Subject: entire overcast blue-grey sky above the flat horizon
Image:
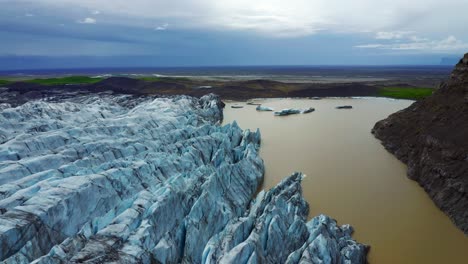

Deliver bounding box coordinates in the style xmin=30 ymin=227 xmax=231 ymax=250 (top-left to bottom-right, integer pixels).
xmin=0 ymin=0 xmax=468 ymax=69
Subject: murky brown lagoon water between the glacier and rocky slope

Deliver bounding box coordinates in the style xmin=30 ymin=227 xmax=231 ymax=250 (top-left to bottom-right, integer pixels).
xmin=224 ymin=98 xmax=468 ymax=264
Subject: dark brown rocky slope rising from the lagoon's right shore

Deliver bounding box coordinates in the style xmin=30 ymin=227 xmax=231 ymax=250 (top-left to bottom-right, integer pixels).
xmin=372 ymin=54 xmax=468 ymax=234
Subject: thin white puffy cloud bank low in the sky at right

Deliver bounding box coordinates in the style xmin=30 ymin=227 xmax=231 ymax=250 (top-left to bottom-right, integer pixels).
xmin=354 ymin=36 xmax=468 ymax=53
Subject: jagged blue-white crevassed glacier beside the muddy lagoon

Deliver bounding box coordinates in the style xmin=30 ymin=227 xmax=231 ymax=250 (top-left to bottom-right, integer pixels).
xmin=0 ymin=93 xmax=369 ymax=263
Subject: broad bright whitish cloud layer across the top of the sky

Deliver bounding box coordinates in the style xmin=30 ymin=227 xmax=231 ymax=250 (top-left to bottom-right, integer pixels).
xmin=18 ymin=0 xmax=468 ymax=39
